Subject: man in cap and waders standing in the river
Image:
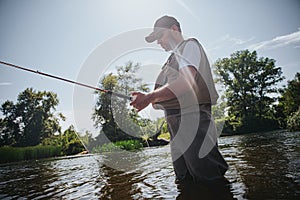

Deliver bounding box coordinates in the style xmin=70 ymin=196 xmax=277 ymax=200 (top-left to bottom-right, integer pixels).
xmin=131 ymin=16 xmax=228 ymax=182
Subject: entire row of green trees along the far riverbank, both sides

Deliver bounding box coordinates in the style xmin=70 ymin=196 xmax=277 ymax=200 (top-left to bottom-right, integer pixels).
xmin=0 ymin=50 xmax=300 ymax=150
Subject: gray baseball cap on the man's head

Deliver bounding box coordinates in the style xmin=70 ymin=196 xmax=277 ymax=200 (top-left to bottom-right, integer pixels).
xmin=145 ymin=15 xmax=180 ymax=43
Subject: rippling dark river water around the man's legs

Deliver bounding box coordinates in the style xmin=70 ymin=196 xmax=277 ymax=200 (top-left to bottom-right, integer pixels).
xmin=0 ymin=131 xmax=300 ymax=200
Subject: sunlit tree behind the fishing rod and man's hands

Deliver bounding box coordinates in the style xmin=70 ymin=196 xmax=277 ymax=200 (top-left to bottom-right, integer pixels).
xmin=92 ymin=62 xmax=148 ymax=142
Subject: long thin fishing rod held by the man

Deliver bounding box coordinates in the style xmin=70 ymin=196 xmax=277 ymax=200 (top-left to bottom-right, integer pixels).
xmin=0 ymin=61 xmax=132 ymax=101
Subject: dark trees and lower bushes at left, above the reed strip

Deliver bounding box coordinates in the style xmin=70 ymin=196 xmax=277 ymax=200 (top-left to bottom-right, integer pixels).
xmin=0 ymin=88 xmax=84 ymax=155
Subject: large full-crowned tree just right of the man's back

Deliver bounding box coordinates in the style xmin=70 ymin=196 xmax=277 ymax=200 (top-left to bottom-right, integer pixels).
xmin=215 ymin=50 xmax=284 ymax=132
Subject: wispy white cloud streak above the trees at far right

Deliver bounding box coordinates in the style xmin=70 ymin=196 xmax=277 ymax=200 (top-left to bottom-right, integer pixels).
xmin=248 ymin=28 xmax=300 ymax=50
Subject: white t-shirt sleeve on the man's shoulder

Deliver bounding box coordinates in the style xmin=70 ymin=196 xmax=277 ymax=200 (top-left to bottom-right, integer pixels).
xmin=178 ymin=41 xmax=201 ymax=69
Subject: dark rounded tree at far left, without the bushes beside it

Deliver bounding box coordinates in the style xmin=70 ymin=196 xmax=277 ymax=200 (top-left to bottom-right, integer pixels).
xmin=0 ymin=88 xmax=64 ymax=146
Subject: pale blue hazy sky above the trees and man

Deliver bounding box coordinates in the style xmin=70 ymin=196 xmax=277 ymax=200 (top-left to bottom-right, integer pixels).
xmin=0 ymin=0 xmax=300 ymax=134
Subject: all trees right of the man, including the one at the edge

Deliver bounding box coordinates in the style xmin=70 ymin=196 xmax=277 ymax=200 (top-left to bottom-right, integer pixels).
xmin=215 ymin=50 xmax=300 ymax=134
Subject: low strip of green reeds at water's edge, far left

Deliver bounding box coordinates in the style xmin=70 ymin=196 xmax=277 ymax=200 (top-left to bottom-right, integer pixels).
xmin=0 ymin=145 xmax=61 ymax=163
